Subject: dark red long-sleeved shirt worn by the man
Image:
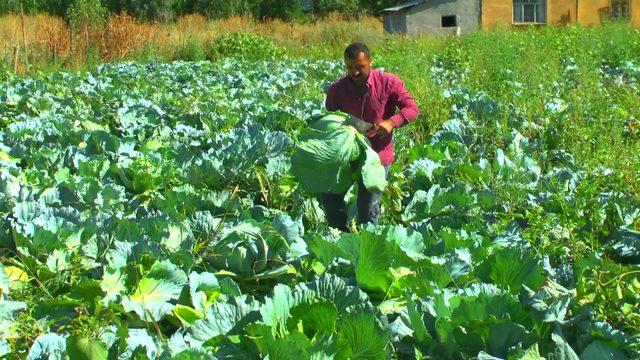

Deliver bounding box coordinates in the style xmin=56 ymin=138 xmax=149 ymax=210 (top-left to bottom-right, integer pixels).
xmin=325 ymin=69 xmax=420 ymax=165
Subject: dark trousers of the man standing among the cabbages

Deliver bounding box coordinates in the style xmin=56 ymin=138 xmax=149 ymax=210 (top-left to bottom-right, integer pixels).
xmin=320 ymin=166 xmax=389 ymax=232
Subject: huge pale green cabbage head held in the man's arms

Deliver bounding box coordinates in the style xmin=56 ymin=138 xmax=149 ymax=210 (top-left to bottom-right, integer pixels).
xmin=291 ymin=113 xmax=387 ymax=194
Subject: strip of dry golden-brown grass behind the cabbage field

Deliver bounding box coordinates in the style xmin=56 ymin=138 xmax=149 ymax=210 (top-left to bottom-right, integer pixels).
xmin=0 ymin=14 xmax=384 ymax=69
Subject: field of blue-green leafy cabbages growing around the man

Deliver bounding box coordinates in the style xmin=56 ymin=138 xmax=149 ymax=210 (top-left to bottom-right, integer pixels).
xmin=0 ymin=58 xmax=640 ymax=360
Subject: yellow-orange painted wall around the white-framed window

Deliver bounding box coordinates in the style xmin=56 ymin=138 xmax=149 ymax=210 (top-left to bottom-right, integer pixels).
xmin=482 ymin=0 xmax=640 ymax=29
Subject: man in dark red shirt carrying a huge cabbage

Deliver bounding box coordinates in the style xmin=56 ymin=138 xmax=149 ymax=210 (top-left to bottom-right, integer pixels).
xmin=321 ymin=43 xmax=419 ymax=231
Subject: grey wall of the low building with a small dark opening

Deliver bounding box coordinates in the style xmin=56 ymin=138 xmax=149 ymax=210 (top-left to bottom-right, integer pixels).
xmin=407 ymin=0 xmax=480 ymax=36
